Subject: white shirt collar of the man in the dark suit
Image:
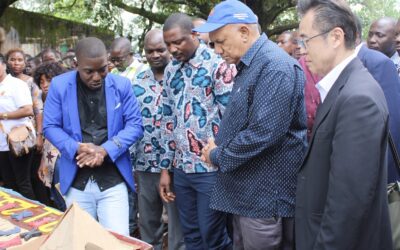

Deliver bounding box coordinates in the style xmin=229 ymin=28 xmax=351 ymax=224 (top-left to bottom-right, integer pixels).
xmin=316 ymin=52 xmax=356 ymax=103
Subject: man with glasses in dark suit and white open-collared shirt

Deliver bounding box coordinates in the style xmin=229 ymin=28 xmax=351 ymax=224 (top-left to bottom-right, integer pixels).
xmin=295 ymin=0 xmax=392 ymax=250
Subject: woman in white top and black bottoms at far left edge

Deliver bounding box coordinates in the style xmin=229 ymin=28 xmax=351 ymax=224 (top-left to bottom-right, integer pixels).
xmin=0 ymin=54 xmax=35 ymax=199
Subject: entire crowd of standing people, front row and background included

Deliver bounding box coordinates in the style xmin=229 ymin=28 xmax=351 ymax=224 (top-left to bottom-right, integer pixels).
xmin=0 ymin=0 xmax=400 ymax=250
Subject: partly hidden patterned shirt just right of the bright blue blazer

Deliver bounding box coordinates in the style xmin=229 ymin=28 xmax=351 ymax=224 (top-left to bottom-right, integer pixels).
xmin=131 ymin=69 xmax=165 ymax=173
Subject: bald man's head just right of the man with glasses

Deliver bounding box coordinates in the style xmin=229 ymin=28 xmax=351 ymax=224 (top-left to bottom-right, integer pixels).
xmin=367 ymin=17 xmax=396 ymax=57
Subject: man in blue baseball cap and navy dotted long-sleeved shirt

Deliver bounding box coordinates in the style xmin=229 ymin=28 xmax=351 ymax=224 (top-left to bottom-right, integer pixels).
xmin=198 ymin=0 xmax=306 ymax=249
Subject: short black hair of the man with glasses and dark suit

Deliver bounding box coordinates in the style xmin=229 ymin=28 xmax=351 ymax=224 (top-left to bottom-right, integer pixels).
xmin=297 ymin=0 xmax=357 ymax=49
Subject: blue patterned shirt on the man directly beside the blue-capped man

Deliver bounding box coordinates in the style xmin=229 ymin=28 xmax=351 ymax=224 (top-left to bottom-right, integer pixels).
xmin=160 ymin=44 xmax=236 ymax=173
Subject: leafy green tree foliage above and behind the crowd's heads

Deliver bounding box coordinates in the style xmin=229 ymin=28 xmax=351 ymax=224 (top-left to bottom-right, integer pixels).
xmin=7 ymin=0 xmax=400 ymax=48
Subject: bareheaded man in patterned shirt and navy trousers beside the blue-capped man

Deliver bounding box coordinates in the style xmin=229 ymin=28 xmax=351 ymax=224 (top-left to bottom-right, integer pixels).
xmin=159 ymin=13 xmax=236 ymax=250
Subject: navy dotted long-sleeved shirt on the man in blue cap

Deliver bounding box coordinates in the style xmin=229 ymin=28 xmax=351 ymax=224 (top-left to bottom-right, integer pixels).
xmin=210 ymin=34 xmax=307 ymax=218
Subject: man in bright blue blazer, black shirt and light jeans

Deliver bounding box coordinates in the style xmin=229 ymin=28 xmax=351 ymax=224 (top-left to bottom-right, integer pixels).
xmin=43 ymin=37 xmax=143 ymax=235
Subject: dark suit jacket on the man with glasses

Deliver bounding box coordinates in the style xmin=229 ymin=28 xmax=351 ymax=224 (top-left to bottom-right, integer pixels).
xmin=295 ymin=58 xmax=392 ymax=250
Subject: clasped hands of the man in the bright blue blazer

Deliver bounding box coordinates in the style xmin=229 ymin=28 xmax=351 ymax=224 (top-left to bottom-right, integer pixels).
xmin=76 ymin=143 xmax=107 ymax=168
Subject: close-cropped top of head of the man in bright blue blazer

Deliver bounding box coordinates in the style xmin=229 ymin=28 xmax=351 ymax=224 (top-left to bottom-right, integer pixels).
xmin=75 ymin=37 xmax=107 ymax=63
